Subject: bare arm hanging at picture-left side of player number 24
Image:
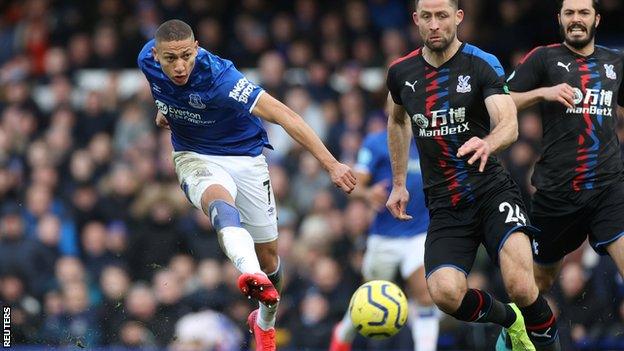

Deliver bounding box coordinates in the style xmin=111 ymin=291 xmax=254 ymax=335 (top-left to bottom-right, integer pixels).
xmin=386 ymin=94 xmax=412 ymax=221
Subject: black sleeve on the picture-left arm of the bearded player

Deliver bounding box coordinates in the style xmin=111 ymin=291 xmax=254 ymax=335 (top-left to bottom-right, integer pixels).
xmin=507 ymin=47 xmax=546 ymax=93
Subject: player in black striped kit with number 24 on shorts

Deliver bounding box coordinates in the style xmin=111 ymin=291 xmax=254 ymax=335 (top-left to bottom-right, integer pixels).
xmin=387 ymin=0 xmax=560 ymax=350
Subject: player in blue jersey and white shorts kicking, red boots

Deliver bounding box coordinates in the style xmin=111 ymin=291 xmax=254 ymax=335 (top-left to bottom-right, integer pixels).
xmin=138 ymin=20 xmax=356 ymax=351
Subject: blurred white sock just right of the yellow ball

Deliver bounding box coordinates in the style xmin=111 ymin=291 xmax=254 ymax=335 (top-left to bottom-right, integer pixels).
xmin=410 ymin=303 xmax=440 ymax=351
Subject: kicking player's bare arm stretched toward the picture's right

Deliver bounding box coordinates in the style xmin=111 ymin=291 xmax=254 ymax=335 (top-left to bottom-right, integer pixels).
xmin=252 ymin=92 xmax=356 ymax=193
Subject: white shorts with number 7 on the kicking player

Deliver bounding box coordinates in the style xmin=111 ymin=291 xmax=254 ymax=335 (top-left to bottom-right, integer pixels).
xmin=173 ymin=151 xmax=277 ymax=243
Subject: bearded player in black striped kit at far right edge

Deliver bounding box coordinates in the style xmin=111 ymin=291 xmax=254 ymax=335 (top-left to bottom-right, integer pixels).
xmin=508 ymin=0 xmax=624 ymax=320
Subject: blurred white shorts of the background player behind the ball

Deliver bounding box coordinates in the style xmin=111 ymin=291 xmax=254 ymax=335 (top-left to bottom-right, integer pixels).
xmin=362 ymin=233 xmax=426 ymax=281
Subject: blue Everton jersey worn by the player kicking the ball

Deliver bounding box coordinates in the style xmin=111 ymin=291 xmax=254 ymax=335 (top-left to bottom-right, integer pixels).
xmin=138 ymin=39 xmax=271 ymax=156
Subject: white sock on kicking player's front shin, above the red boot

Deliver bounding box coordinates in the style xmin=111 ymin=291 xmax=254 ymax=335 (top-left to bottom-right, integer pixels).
xmin=218 ymin=227 xmax=262 ymax=273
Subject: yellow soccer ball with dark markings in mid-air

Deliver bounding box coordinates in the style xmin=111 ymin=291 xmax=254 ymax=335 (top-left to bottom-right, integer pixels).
xmin=349 ymin=280 xmax=407 ymax=339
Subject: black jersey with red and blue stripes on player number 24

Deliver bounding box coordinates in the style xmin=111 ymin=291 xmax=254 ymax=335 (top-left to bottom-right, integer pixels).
xmin=387 ymin=43 xmax=508 ymax=208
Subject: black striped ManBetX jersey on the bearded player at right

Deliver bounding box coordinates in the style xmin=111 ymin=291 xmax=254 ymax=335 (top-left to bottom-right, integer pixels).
xmin=508 ymin=44 xmax=624 ymax=191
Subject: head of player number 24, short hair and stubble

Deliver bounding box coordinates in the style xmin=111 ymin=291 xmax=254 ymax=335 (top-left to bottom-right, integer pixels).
xmin=412 ymin=0 xmax=464 ymax=52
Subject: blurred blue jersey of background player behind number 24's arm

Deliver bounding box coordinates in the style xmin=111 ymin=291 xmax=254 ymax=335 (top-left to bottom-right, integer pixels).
xmin=355 ymin=131 xmax=429 ymax=237
